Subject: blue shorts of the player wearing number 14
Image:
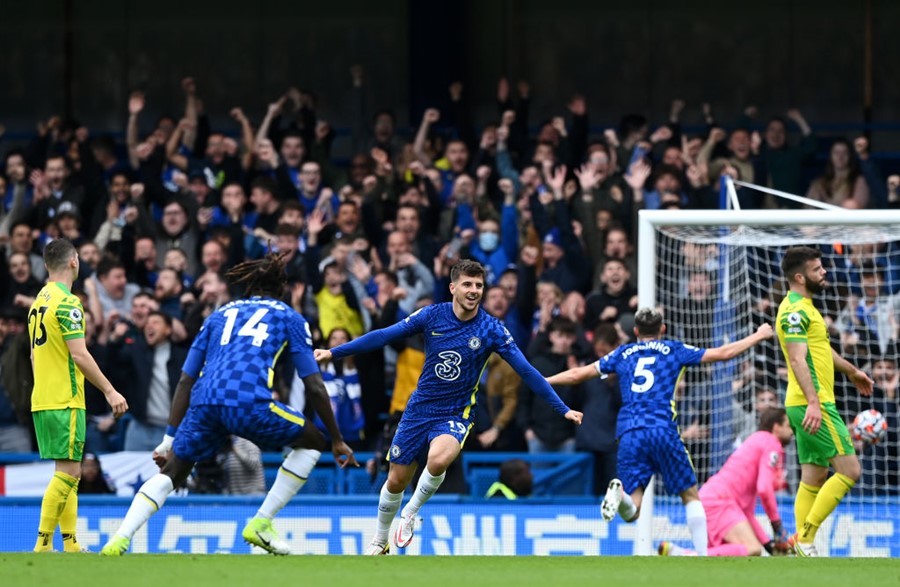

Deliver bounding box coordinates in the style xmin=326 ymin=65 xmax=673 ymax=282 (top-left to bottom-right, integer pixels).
xmin=172 ymin=401 xmax=306 ymax=463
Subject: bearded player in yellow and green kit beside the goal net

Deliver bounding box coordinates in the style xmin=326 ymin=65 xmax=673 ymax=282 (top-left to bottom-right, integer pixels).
xmin=776 ymin=247 xmax=872 ymax=556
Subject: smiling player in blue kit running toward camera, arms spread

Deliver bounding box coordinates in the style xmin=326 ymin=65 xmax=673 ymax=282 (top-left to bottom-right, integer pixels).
xmin=315 ymin=259 xmax=582 ymax=555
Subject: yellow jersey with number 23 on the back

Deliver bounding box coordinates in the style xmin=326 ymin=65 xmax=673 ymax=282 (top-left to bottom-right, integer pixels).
xmin=28 ymin=281 xmax=84 ymax=412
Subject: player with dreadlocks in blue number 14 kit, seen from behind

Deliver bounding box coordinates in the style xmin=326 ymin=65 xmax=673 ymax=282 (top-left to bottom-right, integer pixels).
xmin=101 ymin=253 xmax=358 ymax=556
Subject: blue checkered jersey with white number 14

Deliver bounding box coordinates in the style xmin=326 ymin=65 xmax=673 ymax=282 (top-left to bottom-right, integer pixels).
xmin=184 ymin=297 xmax=319 ymax=407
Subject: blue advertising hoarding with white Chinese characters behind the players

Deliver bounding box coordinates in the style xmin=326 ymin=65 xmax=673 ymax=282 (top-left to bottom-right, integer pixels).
xmin=0 ymin=496 xmax=900 ymax=557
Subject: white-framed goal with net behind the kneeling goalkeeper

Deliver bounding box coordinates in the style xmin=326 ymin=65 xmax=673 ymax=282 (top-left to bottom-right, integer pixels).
xmin=637 ymin=210 xmax=900 ymax=556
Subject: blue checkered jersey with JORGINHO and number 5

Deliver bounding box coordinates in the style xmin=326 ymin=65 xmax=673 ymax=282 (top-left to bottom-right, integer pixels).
xmin=594 ymin=340 xmax=706 ymax=438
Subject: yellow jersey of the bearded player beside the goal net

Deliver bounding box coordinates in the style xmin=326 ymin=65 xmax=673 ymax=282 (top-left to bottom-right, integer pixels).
xmin=775 ymin=292 xmax=834 ymax=406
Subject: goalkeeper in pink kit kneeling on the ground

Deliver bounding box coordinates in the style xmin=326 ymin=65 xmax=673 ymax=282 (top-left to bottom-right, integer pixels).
xmin=659 ymin=408 xmax=794 ymax=556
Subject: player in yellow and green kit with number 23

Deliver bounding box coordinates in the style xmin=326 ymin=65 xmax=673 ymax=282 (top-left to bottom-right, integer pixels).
xmin=28 ymin=239 xmax=128 ymax=552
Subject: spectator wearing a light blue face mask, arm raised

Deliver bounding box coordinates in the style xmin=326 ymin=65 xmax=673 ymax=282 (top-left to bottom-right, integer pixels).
xmin=457 ymin=180 xmax=519 ymax=286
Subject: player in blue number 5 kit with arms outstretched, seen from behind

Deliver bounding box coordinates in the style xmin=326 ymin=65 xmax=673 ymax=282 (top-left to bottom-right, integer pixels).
xmin=547 ymin=308 xmax=773 ymax=556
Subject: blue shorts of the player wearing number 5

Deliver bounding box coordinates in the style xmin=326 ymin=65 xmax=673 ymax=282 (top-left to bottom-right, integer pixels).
xmin=616 ymin=428 xmax=697 ymax=494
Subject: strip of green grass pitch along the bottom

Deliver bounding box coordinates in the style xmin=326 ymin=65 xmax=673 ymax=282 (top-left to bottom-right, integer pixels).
xmin=0 ymin=553 xmax=900 ymax=587
